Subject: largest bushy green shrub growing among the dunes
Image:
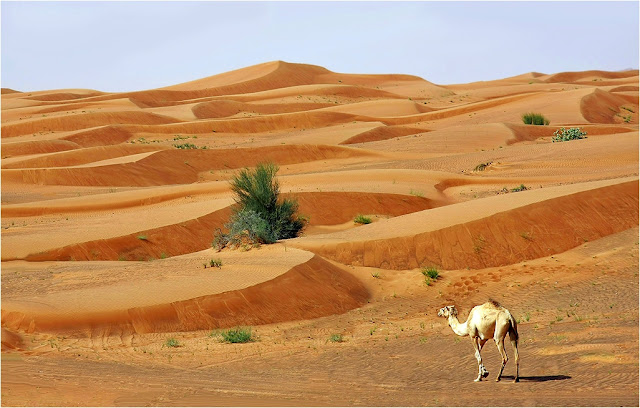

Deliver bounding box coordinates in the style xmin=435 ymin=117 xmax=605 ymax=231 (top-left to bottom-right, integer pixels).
xmin=212 ymin=163 xmax=307 ymax=249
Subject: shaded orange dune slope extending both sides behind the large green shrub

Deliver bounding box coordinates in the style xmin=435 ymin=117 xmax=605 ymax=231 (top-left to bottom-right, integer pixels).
xmin=16 ymin=192 xmax=443 ymax=261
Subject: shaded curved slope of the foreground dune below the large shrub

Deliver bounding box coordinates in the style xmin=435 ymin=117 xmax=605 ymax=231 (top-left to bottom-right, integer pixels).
xmin=2 ymin=256 xmax=369 ymax=337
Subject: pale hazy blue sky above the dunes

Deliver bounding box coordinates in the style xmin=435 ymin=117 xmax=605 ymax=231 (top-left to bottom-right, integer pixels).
xmin=0 ymin=1 xmax=639 ymax=91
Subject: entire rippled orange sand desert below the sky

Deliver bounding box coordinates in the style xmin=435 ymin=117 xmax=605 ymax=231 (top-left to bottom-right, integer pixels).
xmin=1 ymin=61 xmax=639 ymax=406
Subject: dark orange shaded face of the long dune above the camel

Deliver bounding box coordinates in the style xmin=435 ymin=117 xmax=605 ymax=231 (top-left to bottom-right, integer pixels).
xmin=296 ymin=181 xmax=638 ymax=269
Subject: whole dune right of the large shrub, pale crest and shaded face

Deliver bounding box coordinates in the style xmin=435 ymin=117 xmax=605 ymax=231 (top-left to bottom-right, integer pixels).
xmin=292 ymin=180 xmax=638 ymax=269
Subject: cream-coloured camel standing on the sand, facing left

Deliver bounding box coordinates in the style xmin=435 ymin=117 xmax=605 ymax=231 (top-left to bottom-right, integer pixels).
xmin=438 ymin=300 xmax=520 ymax=382
